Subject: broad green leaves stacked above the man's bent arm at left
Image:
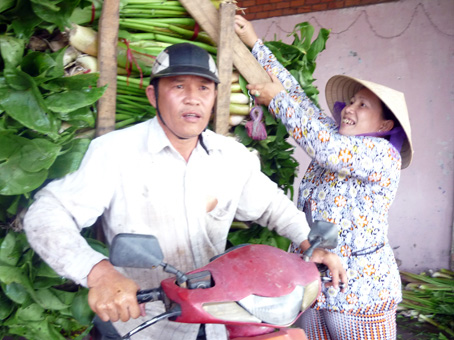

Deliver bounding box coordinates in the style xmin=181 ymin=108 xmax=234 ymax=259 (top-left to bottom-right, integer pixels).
xmin=0 ymin=0 xmax=105 ymax=224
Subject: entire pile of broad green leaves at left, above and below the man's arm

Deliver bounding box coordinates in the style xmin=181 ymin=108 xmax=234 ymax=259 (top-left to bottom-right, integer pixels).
xmin=0 ymin=0 xmax=105 ymax=340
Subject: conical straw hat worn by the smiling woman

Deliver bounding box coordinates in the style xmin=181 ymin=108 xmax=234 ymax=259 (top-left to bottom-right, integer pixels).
xmin=325 ymin=75 xmax=413 ymax=169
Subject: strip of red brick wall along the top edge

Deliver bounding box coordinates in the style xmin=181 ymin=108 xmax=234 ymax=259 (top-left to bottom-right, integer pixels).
xmin=237 ymin=0 xmax=396 ymax=20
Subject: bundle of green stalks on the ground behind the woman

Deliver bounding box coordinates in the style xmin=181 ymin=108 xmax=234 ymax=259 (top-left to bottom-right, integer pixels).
xmin=398 ymin=269 xmax=454 ymax=339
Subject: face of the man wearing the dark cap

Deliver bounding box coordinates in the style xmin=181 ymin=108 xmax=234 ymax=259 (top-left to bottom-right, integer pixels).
xmin=147 ymin=75 xmax=217 ymax=142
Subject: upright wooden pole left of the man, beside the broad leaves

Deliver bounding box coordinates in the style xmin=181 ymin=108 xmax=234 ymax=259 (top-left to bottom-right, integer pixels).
xmin=95 ymin=0 xmax=120 ymax=137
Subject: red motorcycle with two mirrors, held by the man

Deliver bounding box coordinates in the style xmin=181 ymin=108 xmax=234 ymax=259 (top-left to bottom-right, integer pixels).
xmin=110 ymin=221 xmax=337 ymax=340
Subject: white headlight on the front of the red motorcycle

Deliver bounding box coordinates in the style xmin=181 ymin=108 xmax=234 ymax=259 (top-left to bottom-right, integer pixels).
xmin=238 ymin=286 xmax=304 ymax=326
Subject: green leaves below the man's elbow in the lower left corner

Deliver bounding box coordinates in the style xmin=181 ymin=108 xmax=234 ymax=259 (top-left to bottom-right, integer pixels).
xmin=0 ymin=229 xmax=107 ymax=340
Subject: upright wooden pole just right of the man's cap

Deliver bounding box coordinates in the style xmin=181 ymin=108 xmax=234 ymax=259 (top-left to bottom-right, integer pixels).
xmin=214 ymin=2 xmax=236 ymax=135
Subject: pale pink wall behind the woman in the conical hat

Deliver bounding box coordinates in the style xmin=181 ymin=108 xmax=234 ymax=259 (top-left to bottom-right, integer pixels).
xmin=246 ymin=0 xmax=454 ymax=272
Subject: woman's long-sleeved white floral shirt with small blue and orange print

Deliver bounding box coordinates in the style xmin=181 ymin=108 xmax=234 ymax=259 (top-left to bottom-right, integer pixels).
xmin=252 ymin=40 xmax=402 ymax=313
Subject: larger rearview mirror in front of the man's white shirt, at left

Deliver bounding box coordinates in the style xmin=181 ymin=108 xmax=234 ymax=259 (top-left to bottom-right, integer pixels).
xmin=110 ymin=233 xmax=164 ymax=268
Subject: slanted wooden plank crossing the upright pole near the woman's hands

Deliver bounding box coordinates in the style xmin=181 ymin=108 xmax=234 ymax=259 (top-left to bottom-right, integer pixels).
xmin=180 ymin=0 xmax=271 ymax=84
